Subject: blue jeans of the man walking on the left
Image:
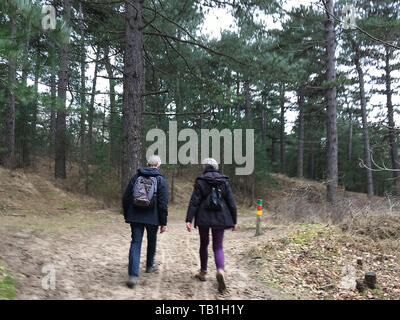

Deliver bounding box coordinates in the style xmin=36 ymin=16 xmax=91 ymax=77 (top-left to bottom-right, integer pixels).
xmin=128 ymin=222 xmax=158 ymax=276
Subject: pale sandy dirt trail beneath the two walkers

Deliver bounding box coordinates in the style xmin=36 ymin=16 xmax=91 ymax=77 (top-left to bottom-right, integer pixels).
xmin=0 ymin=217 xmax=280 ymax=300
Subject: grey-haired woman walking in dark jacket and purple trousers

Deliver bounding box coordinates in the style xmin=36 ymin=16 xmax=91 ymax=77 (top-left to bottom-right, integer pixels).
xmin=186 ymin=158 xmax=237 ymax=293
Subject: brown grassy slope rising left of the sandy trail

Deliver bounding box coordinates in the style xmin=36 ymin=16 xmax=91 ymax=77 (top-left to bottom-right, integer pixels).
xmin=0 ymin=162 xmax=118 ymax=230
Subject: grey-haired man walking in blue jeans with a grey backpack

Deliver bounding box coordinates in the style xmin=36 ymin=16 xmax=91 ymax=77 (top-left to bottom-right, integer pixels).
xmin=122 ymin=155 xmax=168 ymax=288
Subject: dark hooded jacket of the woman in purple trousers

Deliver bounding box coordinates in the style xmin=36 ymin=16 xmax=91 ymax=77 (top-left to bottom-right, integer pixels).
xmin=186 ymin=169 xmax=237 ymax=228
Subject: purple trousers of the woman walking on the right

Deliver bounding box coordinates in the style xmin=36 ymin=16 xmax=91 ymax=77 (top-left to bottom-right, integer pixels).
xmin=199 ymin=226 xmax=225 ymax=271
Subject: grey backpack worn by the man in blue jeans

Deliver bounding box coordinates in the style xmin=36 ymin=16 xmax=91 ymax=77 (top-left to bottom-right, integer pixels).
xmin=132 ymin=176 xmax=157 ymax=208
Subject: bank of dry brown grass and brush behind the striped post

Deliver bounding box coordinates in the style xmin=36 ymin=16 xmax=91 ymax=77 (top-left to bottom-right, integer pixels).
xmin=266 ymin=175 xmax=400 ymax=226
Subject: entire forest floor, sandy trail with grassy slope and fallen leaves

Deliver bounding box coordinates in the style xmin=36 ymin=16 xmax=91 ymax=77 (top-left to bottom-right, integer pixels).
xmin=0 ymin=167 xmax=400 ymax=300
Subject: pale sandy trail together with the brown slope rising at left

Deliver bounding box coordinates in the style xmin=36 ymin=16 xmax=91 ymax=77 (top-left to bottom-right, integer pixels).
xmin=0 ymin=168 xmax=287 ymax=300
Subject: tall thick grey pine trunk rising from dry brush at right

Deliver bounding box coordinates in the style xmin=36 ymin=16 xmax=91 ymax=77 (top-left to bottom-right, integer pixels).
xmin=325 ymin=0 xmax=338 ymax=203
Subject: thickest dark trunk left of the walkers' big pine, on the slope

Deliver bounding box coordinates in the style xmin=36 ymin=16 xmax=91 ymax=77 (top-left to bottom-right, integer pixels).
xmin=55 ymin=0 xmax=71 ymax=179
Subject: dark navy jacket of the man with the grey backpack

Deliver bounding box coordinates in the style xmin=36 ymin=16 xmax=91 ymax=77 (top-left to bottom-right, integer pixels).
xmin=122 ymin=167 xmax=168 ymax=226
